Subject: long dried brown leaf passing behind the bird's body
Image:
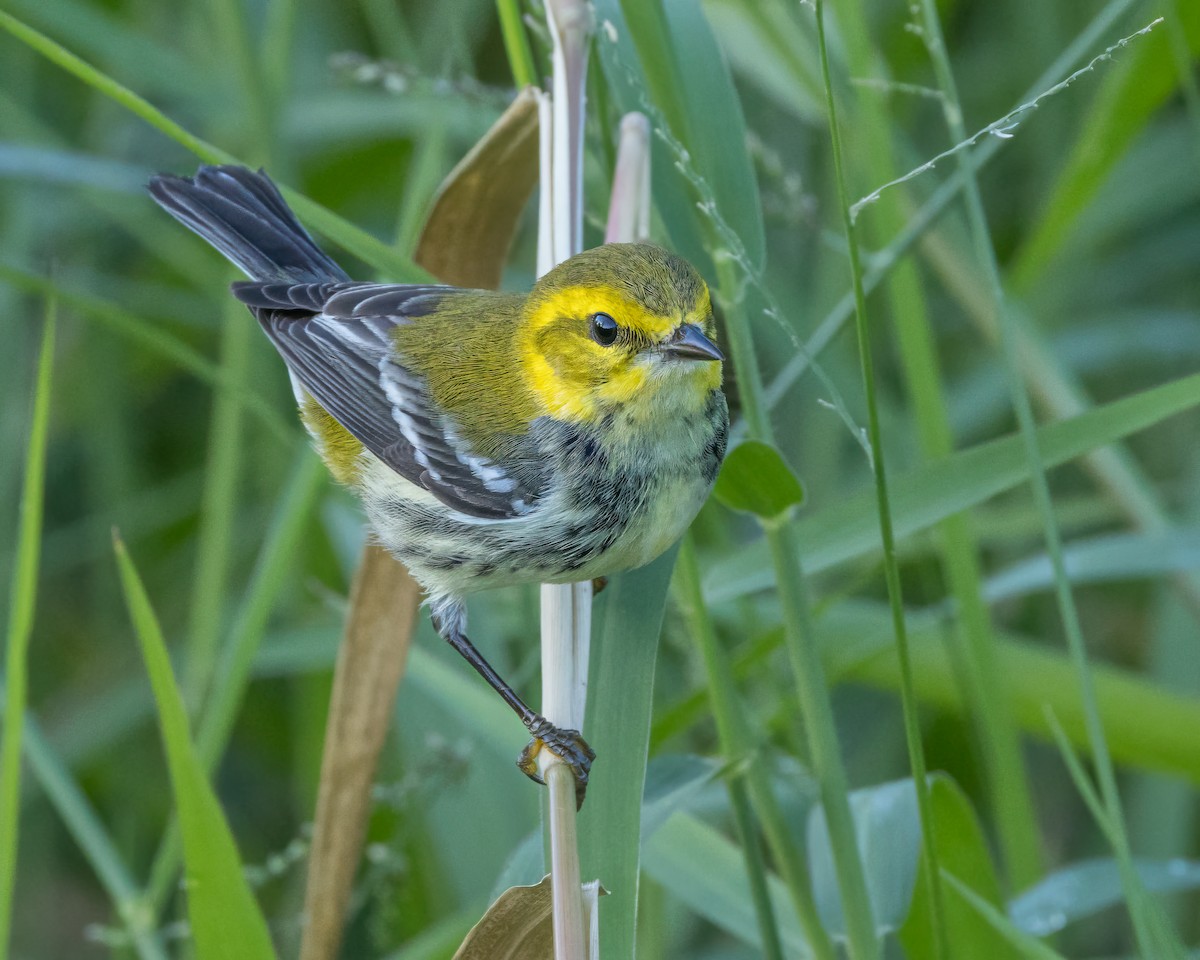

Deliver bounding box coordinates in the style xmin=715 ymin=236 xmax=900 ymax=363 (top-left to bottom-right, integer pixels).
xmin=300 ymin=90 xmax=538 ymax=960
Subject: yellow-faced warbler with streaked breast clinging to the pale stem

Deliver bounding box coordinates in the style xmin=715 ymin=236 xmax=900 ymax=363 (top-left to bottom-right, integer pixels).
xmin=149 ymin=166 xmax=728 ymax=804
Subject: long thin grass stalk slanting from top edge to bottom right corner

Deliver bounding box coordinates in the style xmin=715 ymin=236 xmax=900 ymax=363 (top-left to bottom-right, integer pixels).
xmin=907 ymin=0 xmax=1182 ymax=956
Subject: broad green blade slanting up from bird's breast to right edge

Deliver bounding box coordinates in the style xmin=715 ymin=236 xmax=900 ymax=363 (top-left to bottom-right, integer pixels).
xmin=704 ymin=374 xmax=1200 ymax=602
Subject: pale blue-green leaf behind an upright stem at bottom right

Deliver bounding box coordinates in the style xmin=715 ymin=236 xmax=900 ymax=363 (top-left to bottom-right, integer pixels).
xmin=808 ymin=779 xmax=920 ymax=941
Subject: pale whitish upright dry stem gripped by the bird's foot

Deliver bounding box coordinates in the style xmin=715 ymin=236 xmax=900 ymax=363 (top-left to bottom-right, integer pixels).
xmin=538 ymin=0 xmax=592 ymax=960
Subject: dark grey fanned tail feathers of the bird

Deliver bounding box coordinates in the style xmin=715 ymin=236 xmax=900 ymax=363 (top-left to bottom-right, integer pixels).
xmin=150 ymin=167 xmax=349 ymax=283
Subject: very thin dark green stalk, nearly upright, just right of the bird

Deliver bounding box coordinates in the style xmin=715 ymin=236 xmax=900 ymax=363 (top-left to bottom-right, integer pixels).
xmin=816 ymin=0 xmax=947 ymax=958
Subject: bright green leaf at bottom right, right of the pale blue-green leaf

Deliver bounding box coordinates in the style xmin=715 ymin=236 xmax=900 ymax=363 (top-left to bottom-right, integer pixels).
xmin=900 ymin=773 xmax=1021 ymax=960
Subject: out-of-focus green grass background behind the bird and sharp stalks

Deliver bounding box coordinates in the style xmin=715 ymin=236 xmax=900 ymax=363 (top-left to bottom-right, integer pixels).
xmin=0 ymin=0 xmax=1200 ymax=960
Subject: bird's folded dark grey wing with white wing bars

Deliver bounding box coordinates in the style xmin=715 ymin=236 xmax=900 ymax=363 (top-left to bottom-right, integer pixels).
xmin=233 ymin=282 xmax=540 ymax=520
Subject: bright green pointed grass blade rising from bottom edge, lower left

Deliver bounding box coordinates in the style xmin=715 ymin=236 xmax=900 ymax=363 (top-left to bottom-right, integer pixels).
xmin=114 ymin=536 xmax=275 ymax=960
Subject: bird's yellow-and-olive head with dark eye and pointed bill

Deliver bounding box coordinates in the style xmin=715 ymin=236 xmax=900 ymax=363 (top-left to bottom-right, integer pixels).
xmin=518 ymin=244 xmax=725 ymax=421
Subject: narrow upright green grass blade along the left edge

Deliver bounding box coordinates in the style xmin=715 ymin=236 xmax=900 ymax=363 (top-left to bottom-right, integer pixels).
xmin=0 ymin=299 xmax=58 ymax=960
